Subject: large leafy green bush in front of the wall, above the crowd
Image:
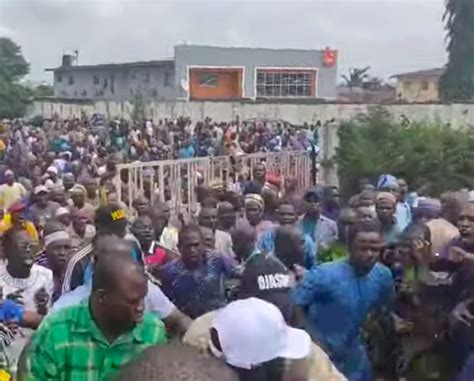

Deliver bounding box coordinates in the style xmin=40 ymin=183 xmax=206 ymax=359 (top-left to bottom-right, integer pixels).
xmin=336 ymin=107 xmax=474 ymax=195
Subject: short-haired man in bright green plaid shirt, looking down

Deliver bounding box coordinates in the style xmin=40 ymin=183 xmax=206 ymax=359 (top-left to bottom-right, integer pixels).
xmin=28 ymin=248 xmax=166 ymax=380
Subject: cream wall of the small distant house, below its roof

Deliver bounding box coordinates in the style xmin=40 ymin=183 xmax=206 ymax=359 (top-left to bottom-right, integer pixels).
xmin=397 ymin=78 xmax=439 ymax=102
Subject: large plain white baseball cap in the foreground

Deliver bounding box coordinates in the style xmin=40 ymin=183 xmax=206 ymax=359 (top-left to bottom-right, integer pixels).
xmin=213 ymin=298 xmax=311 ymax=369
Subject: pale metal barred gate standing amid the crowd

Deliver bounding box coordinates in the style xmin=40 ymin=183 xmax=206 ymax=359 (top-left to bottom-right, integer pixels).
xmin=115 ymin=151 xmax=313 ymax=215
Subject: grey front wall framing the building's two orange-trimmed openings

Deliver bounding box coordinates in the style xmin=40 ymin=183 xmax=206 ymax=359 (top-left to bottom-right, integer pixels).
xmin=175 ymin=45 xmax=337 ymax=99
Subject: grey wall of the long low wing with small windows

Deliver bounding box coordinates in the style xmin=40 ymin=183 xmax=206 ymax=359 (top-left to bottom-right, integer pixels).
xmin=54 ymin=63 xmax=176 ymax=101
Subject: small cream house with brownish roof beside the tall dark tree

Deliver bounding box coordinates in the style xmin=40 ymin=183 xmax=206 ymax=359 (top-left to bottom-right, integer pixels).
xmin=390 ymin=68 xmax=444 ymax=103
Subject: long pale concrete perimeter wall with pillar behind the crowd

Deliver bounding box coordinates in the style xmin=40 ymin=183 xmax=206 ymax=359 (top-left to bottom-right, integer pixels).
xmin=28 ymin=100 xmax=474 ymax=184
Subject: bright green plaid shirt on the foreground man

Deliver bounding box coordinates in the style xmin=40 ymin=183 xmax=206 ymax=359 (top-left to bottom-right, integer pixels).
xmin=27 ymin=299 xmax=166 ymax=381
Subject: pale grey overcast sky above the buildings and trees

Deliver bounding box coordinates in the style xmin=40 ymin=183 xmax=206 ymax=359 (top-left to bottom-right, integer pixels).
xmin=0 ymin=0 xmax=446 ymax=81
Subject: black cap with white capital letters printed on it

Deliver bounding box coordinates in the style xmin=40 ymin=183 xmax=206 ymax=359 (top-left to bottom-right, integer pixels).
xmin=239 ymin=254 xmax=293 ymax=322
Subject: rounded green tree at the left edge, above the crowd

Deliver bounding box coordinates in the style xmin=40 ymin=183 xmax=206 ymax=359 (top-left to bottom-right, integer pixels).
xmin=0 ymin=37 xmax=30 ymax=118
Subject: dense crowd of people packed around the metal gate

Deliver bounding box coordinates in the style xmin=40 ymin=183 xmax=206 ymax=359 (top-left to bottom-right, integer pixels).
xmin=0 ymin=117 xmax=474 ymax=381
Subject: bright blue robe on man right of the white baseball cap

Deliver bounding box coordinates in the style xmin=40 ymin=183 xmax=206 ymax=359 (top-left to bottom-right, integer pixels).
xmin=293 ymin=258 xmax=394 ymax=381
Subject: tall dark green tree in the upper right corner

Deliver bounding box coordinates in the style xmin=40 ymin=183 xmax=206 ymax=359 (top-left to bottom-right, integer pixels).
xmin=439 ymin=0 xmax=474 ymax=102
